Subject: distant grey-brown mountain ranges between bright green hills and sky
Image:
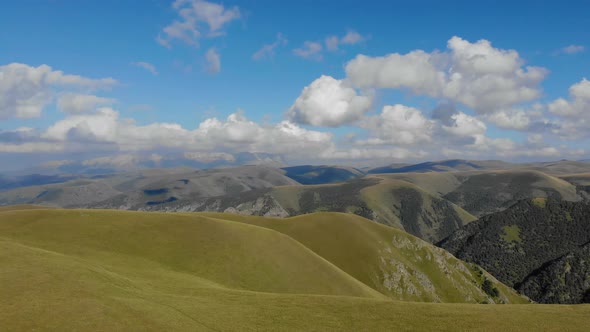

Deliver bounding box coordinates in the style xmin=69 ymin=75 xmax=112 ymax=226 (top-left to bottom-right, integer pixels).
xmin=0 ymin=166 xmax=590 ymax=243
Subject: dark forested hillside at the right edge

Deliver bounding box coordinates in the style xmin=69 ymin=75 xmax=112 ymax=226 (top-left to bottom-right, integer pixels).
xmin=440 ymin=198 xmax=590 ymax=303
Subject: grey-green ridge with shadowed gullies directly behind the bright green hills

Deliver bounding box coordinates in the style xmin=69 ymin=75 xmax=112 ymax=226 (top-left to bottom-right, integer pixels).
xmin=145 ymin=176 xmax=476 ymax=242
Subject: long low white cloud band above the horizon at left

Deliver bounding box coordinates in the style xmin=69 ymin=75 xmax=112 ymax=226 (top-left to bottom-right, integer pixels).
xmin=0 ymin=107 xmax=334 ymax=162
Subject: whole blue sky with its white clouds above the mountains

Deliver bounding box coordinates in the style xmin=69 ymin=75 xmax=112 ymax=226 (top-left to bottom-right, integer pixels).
xmin=0 ymin=0 xmax=590 ymax=168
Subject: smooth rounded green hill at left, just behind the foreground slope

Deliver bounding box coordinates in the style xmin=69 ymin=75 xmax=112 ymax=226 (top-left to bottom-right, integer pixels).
xmin=0 ymin=210 xmax=378 ymax=297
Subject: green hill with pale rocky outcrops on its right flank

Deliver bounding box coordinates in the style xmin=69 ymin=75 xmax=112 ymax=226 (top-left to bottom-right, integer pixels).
xmin=206 ymin=213 xmax=525 ymax=303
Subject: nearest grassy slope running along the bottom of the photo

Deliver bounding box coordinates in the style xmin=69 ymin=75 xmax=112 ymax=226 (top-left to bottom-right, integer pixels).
xmin=0 ymin=241 xmax=590 ymax=331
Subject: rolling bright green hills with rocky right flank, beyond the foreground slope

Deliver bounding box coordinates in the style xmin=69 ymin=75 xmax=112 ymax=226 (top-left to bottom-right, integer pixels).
xmin=0 ymin=208 xmax=522 ymax=302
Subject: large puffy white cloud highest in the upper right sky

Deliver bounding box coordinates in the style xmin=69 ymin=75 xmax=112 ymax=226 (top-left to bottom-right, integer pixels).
xmin=346 ymin=37 xmax=547 ymax=114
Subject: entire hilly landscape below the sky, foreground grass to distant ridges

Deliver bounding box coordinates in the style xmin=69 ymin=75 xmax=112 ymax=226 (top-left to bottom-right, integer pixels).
xmin=0 ymin=160 xmax=590 ymax=330
